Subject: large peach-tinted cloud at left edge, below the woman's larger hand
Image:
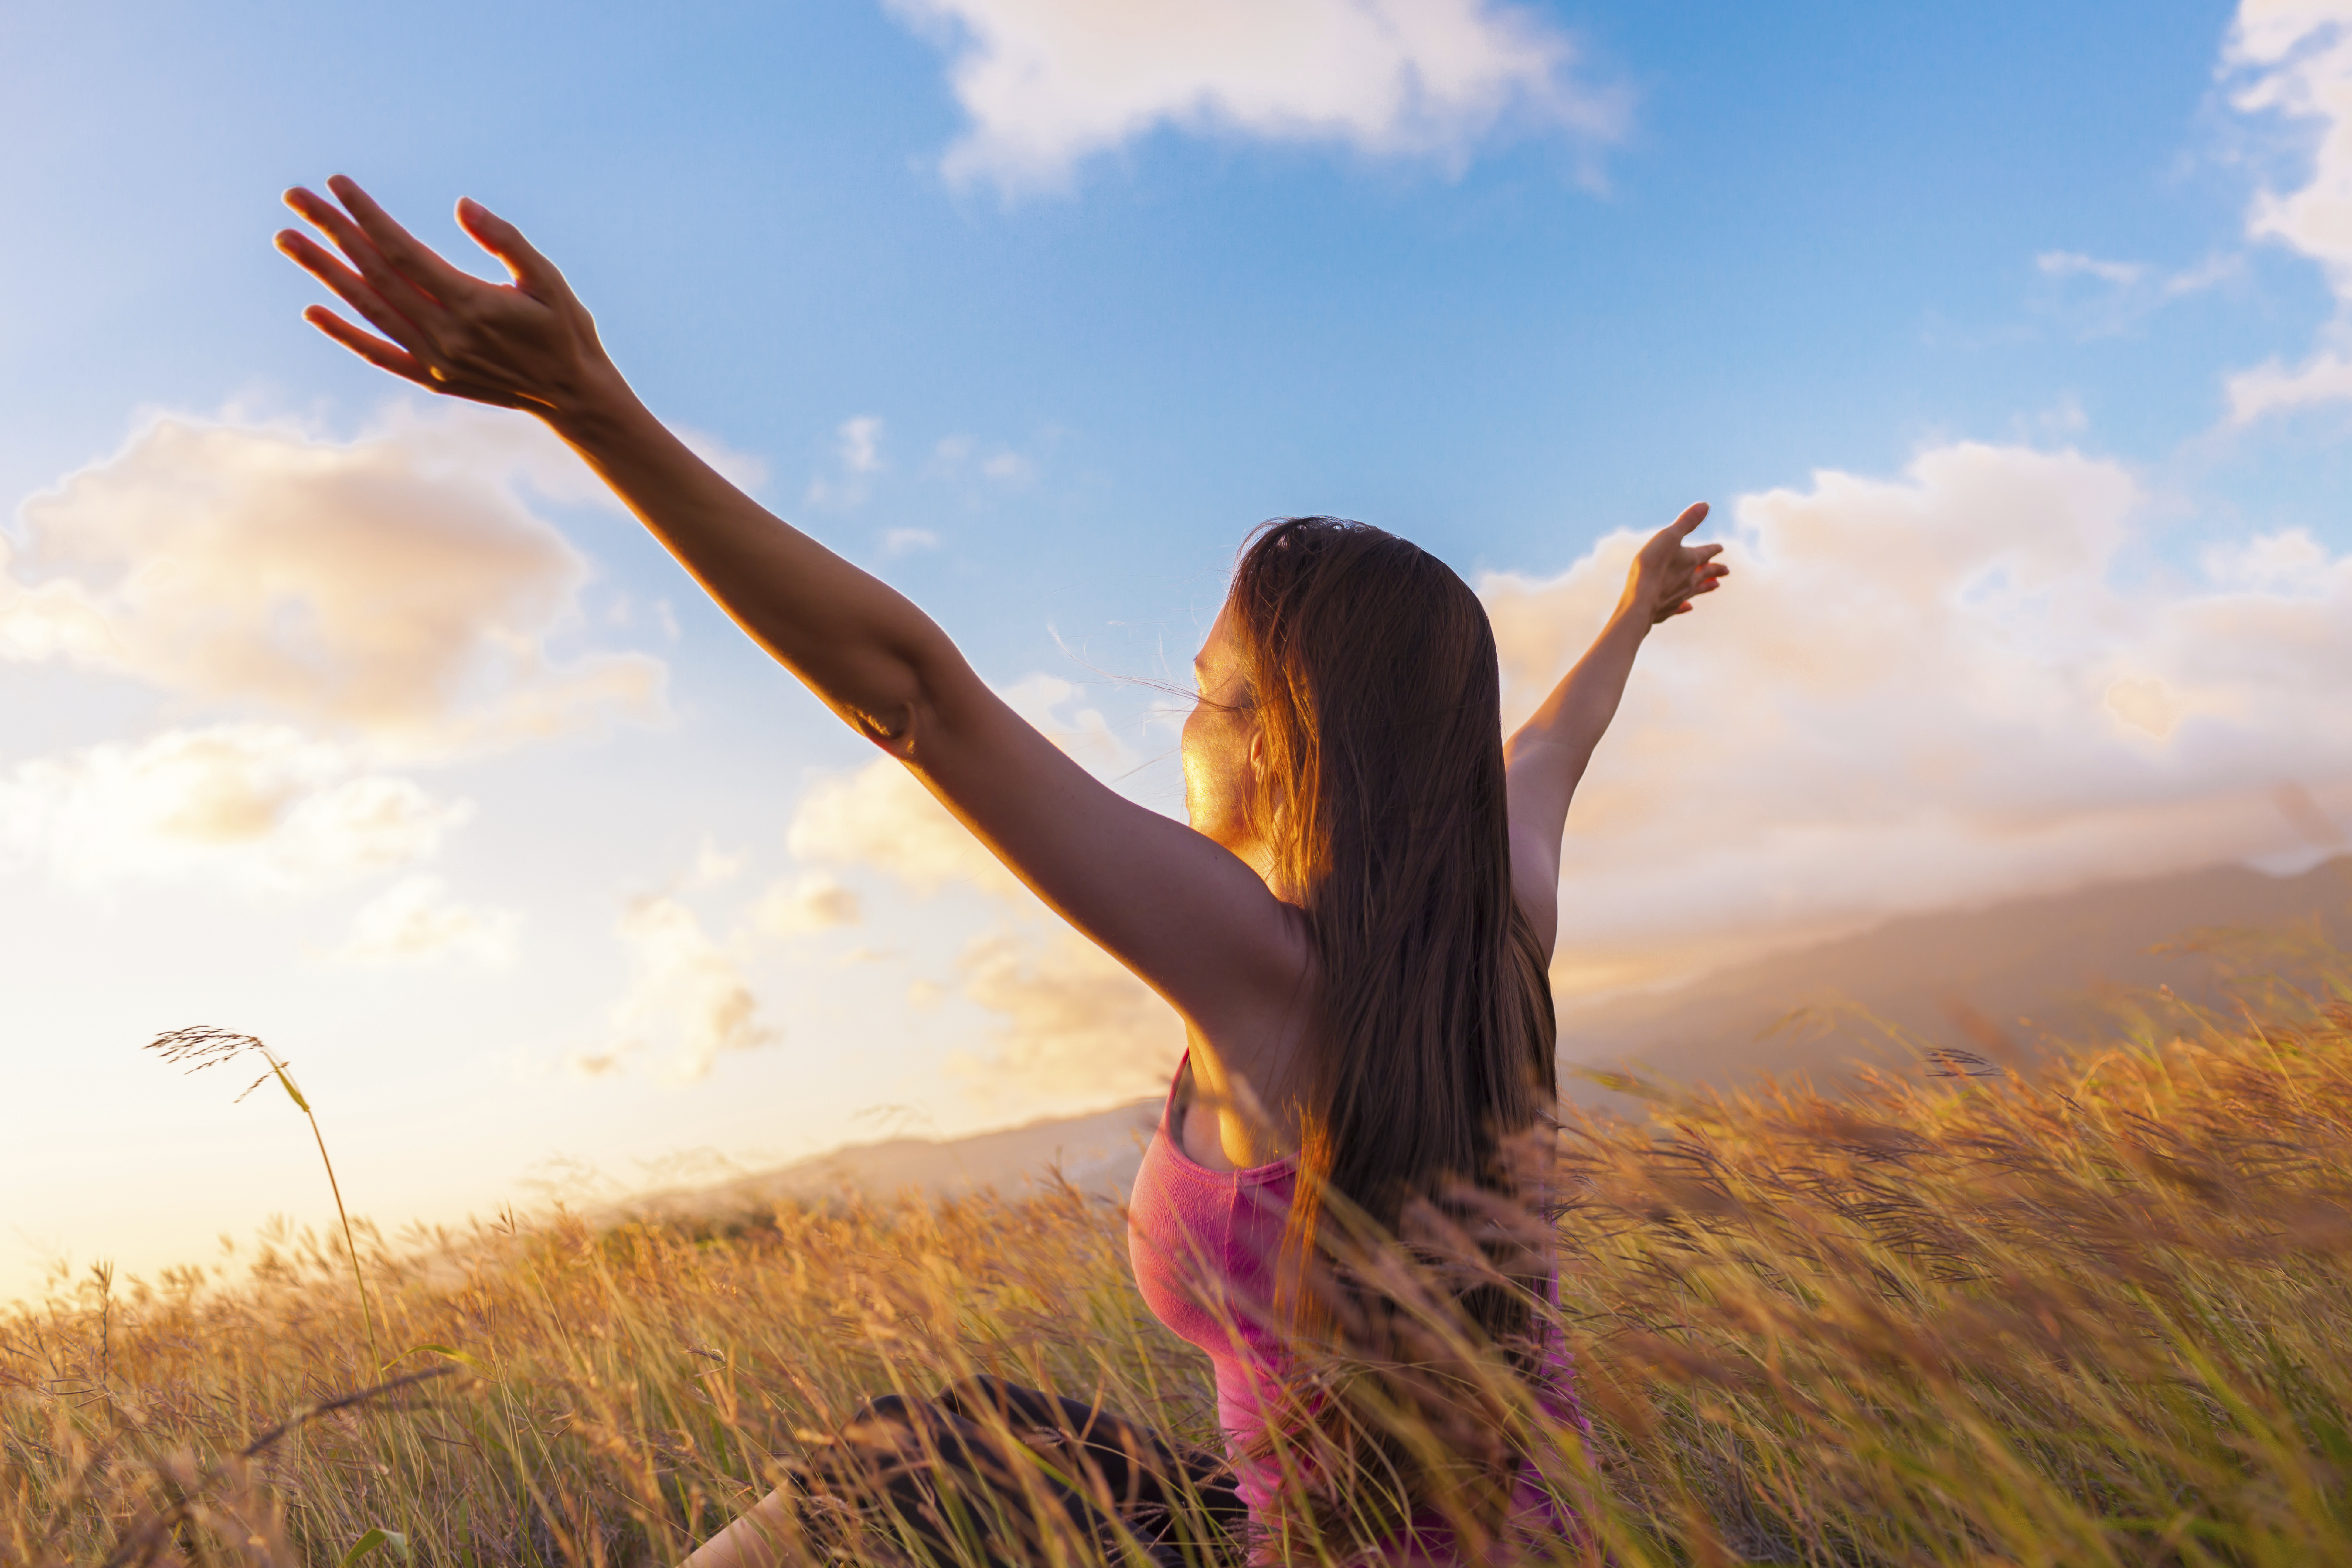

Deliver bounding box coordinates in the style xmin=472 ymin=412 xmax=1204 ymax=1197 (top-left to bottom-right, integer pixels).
xmin=0 ymin=418 xmax=663 ymax=752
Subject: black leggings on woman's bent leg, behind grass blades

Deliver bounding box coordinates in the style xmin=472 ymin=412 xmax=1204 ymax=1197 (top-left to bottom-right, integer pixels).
xmin=795 ymin=1377 xmax=1246 ymax=1568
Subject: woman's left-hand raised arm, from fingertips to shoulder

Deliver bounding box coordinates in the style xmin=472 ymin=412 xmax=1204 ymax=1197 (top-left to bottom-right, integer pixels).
xmin=277 ymin=176 xmax=1305 ymax=1039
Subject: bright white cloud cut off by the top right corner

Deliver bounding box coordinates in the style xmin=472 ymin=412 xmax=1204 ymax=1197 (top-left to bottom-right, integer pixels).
xmin=2225 ymin=0 xmax=2352 ymax=421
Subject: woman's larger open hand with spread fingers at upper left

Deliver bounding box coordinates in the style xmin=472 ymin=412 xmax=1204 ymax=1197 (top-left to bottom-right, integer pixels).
xmin=277 ymin=174 xmax=621 ymax=418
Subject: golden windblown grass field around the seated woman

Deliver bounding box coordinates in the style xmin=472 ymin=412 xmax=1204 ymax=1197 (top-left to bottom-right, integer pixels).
xmin=0 ymin=971 xmax=2352 ymax=1568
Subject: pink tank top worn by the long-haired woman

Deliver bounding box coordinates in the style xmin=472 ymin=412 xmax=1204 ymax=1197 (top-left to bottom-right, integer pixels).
xmin=1127 ymin=1053 xmax=1590 ymax=1566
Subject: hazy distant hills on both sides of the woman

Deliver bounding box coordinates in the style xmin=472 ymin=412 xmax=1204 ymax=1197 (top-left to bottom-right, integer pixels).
xmin=626 ymin=856 xmax=2352 ymax=1216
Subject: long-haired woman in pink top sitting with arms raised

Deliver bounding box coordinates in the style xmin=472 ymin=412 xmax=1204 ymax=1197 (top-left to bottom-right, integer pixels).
xmin=277 ymin=179 xmax=1726 ymax=1563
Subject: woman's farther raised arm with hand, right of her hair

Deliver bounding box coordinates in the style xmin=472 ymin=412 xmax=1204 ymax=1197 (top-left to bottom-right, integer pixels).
xmin=1503 ymin=501 xmax=1731 ymax=952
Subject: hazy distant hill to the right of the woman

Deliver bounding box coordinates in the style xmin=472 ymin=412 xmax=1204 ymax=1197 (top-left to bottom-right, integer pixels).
xmin=1559 ymin=856 xmax=2352 ymax=1107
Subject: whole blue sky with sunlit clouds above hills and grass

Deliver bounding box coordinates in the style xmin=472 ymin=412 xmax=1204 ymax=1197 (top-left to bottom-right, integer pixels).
xmin=0 ymin=0 xmax=2352 ymax=1293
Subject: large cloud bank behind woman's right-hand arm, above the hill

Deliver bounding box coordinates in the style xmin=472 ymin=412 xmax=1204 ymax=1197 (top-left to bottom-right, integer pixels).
xmin=1482 ymin=444 xmax=2352 ymax=990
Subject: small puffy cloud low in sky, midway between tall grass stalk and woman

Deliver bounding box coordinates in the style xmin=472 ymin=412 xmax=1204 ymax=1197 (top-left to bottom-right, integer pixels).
xmin=593 ymin=896 xmax=778 ymax=1084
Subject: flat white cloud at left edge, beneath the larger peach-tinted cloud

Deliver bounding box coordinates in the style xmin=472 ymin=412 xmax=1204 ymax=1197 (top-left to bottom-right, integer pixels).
xmin=0 ymin=724 xmax=473 ymax=891
